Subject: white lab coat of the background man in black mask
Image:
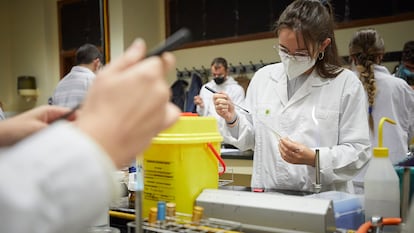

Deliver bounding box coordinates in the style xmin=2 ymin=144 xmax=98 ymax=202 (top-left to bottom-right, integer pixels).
xmin=197 ymin=76 xmax=245 ymax=135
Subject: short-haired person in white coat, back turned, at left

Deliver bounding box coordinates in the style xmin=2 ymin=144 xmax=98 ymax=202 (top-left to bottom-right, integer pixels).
xmin=49 ymin=44 xmax=103 ymax=108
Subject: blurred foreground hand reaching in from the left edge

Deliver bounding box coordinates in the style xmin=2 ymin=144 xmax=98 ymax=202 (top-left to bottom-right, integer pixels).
xmin=0 ymin=105 xmax=74 ymax=146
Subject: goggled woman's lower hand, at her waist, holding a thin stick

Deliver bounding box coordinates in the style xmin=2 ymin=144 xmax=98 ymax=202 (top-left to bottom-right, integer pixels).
xmin=279 ymin=138 xmax=315 ymax=167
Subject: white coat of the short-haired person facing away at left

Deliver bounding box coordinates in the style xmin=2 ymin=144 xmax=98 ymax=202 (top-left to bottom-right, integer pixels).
xmin=52 ymin=66 xmax=95 ymax=108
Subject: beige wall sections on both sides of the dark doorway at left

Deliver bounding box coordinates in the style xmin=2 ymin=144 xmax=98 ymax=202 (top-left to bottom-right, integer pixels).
xmin=0 ymin=0 xmax=165 ymax=115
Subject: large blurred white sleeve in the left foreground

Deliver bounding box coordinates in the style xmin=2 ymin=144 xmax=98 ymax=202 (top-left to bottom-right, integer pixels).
xmin=0 ymin=123 xmax=117 ymax=233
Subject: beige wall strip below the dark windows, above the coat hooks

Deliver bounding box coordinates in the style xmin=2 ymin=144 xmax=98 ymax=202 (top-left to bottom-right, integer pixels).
xmin=169 ymin=20 xmax=414 ymax=81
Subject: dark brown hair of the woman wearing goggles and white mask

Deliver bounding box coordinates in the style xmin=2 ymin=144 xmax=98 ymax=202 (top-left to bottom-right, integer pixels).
xmin=275 ymin=0 xmax=343 ymax=78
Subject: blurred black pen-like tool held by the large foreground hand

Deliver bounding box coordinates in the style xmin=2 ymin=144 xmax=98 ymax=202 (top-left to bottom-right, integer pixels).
xmin=56 ymin=28 xmax=191 ymax=120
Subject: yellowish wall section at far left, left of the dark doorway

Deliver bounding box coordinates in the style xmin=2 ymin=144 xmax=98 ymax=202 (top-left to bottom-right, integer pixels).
xmin=0 ymin=0 xmax=58 ymax=113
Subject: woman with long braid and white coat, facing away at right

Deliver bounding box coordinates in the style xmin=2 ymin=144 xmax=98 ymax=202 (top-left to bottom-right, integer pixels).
xmin=349 ymin=28 xmax=414 ymax=191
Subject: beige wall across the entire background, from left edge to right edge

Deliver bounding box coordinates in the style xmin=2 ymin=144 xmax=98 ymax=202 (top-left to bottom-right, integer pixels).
xmin=0 ymin=0 xmax=414 ymax=113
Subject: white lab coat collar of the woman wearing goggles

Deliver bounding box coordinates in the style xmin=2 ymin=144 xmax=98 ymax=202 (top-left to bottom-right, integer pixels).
xmin=271 ymin=69 xmax=330 ymax=108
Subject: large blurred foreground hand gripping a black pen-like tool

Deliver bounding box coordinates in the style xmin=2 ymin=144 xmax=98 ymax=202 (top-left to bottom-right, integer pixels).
xmin=74 ymin=40 xmax=180 ymax=168
